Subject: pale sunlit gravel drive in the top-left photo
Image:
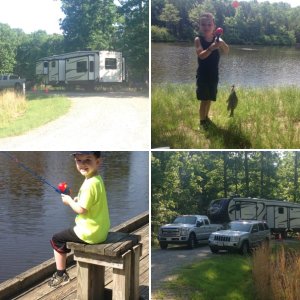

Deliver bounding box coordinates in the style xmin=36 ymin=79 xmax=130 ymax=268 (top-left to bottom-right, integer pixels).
xmin=0 ymin=92 xmax=150 ymax=151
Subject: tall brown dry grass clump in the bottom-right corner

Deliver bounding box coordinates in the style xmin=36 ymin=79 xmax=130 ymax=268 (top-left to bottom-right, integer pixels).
xmin=253 ymin=246 xmax=300 ymax=300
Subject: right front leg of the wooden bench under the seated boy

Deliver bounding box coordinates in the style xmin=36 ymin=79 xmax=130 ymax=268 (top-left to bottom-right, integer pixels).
xmin=112 ymin=250 xmax=131 ymax=300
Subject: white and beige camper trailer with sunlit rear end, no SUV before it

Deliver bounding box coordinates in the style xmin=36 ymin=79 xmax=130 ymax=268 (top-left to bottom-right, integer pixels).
xmin=36 ymin=51 xmax=126 ymax=87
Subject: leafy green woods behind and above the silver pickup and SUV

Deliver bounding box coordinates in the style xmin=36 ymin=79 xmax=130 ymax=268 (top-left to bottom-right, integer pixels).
xmin=151 ymin=151 xmax=300 ymax=224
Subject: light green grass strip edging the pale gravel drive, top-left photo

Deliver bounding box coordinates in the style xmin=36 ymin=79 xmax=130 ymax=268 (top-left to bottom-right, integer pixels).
xmin=0 ymin=94 xmax=71 ymax=138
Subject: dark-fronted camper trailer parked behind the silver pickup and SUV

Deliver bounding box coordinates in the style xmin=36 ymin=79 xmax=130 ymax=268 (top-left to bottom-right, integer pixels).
xmin=207 ymin=197 xmax=300 ymax=234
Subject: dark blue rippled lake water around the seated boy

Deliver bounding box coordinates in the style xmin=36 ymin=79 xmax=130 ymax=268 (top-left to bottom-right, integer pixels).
xmin=0 ymin=152 xmax=149 ymax=282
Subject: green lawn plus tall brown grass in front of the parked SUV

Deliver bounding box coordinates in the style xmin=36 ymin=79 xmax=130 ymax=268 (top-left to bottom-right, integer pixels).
xmin=153 ymin=240 xmax=300 ymax=300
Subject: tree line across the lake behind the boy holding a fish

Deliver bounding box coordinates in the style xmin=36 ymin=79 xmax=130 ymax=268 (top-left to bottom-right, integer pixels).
xmin=151 ymin=0 xmax=300 ymax=45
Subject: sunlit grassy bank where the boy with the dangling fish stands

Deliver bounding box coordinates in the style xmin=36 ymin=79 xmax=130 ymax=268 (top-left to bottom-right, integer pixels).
xmin=151 ymin=84 xmax=300 ymax=149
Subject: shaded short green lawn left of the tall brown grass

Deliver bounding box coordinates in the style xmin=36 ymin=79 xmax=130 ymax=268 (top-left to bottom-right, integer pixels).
xmin=156 ymin=254 xmax=255 ymax=300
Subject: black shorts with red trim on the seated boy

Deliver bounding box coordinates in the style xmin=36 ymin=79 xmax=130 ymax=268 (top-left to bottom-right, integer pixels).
xmin=50 ymin=228 xmax=87 ymax=253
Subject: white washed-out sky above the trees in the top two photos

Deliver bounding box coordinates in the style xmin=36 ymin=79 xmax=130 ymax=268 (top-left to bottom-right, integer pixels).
xmin=0 ymin=0 xmax=300 ymax=34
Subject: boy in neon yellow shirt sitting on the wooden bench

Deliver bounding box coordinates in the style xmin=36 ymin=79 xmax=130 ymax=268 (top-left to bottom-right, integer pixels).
xmin=48 ymin=151 xmax=110 ymax=287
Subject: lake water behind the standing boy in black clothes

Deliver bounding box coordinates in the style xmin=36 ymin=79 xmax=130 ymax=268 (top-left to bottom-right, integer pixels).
xmin=151 ymin=43 xmax=300 ymax=87
